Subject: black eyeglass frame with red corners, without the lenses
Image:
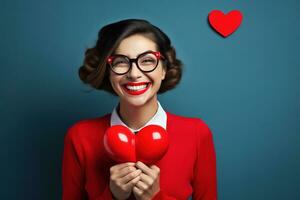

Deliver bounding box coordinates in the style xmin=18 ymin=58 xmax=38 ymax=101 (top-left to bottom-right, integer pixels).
xmin=107 ymin=51 xmax=165 ymax=75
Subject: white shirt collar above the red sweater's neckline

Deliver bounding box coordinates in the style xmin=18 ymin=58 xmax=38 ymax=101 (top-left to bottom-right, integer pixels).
xmin=110 ymin=101 xmax=167 ymax=132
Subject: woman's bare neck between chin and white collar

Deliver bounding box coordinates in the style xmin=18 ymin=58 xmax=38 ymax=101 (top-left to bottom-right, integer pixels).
xmin=118 ymin=98 xmax=158 ymax=129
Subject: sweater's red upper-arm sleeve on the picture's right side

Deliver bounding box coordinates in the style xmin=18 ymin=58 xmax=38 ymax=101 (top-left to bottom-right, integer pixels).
xmin=192 ymin=119 xmax=217 ymax=200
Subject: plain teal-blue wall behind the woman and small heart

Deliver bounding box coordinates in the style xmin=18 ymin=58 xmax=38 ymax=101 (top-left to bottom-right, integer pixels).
xmin=0 ymin=0 xmax=300 ymax=200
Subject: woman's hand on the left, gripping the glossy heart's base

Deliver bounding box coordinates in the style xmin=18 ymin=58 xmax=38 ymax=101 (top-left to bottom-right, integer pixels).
xmin=109 ymin=162 xmax=142 ymax=200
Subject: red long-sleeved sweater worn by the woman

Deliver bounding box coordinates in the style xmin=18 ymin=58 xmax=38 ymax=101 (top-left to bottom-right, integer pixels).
xmin=62 ymin=111 xmax=217 ymax=200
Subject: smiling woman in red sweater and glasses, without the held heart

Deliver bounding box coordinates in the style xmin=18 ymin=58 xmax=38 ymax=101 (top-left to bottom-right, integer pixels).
xmin=62 ymin=19 xmax=217 ymax=200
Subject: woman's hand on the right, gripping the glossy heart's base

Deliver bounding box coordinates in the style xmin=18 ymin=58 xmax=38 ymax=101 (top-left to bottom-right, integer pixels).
xmin=133 ymin=161 xmax=160 ymax=200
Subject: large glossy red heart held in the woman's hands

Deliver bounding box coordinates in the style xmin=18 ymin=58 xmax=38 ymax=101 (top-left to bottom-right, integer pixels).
xmin=104 ymin=125 xmax=169 ymax=164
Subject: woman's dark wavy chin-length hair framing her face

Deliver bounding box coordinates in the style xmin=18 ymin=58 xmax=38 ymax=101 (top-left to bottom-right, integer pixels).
xmin=78 ymin=19 xmax=183 ymax=96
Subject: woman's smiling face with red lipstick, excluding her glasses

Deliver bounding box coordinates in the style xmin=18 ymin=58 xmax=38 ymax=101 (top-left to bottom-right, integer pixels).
xmin=109 ymin=34 xmax=165 ymax=106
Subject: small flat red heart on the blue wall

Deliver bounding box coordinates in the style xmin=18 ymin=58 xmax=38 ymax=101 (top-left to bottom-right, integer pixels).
xmin=208 ymin=10 xmax=243 ymax=37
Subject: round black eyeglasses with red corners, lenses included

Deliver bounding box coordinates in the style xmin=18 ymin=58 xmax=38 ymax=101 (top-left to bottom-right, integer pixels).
xmin=107 ymin=51 xmax=165 ymax=75
